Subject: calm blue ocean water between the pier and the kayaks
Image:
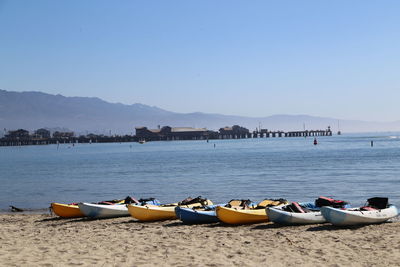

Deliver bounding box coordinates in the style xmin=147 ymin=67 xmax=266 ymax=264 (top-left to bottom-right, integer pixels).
xmin=0 ymin=133 xmax=400 ymax=211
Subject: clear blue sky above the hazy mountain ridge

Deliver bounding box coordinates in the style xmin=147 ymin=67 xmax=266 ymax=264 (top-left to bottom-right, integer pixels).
xmin=0 ymin=0 xmax=400 ymax=121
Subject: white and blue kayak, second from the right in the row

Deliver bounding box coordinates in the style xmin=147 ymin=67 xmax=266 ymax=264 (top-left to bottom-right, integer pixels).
xmin=266 ymin=203 xmax=326 ymax=225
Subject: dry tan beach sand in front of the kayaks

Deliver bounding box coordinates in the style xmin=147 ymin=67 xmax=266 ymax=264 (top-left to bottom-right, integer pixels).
xmin=0 ymin=214 xmax=400 ymax=266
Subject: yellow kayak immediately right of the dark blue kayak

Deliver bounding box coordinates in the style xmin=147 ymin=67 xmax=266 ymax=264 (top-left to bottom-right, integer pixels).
xmin=216 ymin=199 xmax=287 ymax=224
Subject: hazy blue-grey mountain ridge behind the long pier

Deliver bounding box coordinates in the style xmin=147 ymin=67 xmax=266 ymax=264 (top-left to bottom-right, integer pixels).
xmin=0 ymin=90 xmax=400 ymax=134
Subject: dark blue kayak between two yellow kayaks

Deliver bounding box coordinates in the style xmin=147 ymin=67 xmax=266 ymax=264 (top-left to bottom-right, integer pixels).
xmin=175 ymin=204 xmax=225 ymax=224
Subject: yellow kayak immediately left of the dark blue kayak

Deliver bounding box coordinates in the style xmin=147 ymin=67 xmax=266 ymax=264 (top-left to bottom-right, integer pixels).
xmin=128 ymin=200 xmax=213 ymax=222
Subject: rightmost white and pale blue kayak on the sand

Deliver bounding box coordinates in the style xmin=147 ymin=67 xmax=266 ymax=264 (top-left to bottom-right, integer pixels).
xmin=321 ymin=205 xmax=399 ymax=226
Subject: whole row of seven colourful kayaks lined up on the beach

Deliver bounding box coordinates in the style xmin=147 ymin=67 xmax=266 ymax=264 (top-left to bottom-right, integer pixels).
xmin=51 ymin=197 xmax=399 ymax=225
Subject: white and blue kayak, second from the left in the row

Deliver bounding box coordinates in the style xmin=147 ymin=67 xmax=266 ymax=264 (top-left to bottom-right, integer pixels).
xmin=78 ymin=202 xmax=130 ymax=219
